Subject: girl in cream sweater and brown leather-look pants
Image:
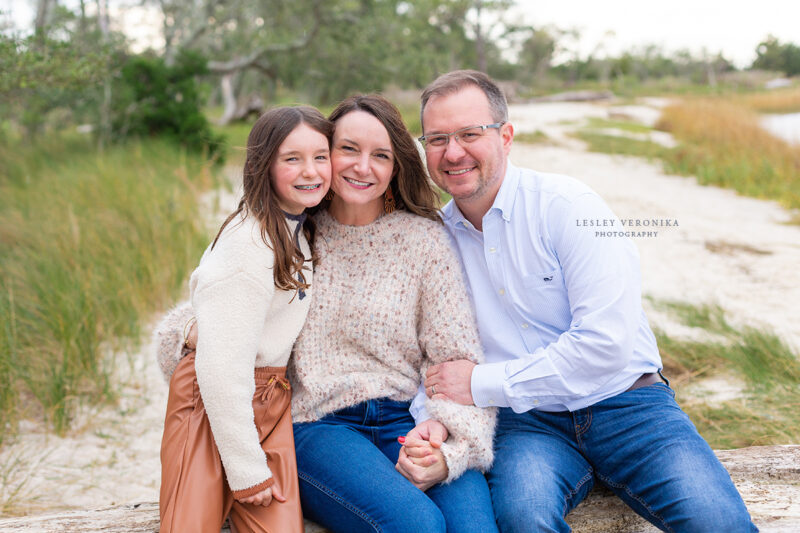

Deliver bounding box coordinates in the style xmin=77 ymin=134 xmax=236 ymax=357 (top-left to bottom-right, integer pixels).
xmin=159 ymin=106 xmax=332 ymax=533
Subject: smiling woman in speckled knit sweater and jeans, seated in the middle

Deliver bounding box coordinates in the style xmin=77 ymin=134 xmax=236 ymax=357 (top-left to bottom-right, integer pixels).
xmin=157 ymin=95 xmax=496 ymax=533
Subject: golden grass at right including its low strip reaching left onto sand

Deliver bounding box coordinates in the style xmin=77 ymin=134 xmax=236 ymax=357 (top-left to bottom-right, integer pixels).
xmin=575 ymin=94 xmax=800 ymax=216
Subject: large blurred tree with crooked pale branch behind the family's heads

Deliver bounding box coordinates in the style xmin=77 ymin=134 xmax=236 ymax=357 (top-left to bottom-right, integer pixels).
xmin=150 ymin=0 xmax=512 ymax=118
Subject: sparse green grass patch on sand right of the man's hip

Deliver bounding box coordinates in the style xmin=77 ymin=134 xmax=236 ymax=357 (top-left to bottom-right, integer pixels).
xmin=655 ymin=302 xmax=800 ymax=448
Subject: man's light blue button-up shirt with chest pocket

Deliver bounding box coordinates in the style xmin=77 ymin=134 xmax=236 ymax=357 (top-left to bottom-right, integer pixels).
xmin=442 ymin=163 xmax=662 ymax=412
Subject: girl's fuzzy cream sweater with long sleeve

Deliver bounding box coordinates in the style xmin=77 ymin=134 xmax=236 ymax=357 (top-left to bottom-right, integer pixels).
xmin=189 ymin=213 xmax=312 ymax=492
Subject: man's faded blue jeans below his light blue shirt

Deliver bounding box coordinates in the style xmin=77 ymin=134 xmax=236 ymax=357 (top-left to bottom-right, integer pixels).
xmin=487 ymin=383 xmax=758 ymax=533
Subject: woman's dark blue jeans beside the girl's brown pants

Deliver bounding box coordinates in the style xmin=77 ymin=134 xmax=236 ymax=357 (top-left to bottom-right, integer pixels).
xmin=294 ymin=399 xmax=497 ymax=533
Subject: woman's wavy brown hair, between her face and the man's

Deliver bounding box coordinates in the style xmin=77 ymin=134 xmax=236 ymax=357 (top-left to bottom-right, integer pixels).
xmin=328 ymin=94 xmax=441 ymax=222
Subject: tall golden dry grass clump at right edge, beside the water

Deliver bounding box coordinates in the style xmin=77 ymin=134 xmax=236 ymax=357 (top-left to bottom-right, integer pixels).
xmin=657 ymin=99 xmax=800 ymax=208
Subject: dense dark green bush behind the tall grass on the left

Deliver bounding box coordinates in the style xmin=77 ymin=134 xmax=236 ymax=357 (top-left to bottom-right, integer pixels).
xmin=112 ymin=51 xmax=222 ymax=156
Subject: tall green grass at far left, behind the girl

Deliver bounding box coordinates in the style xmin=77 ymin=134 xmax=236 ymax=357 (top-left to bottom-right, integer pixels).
xmin=0 ymin=136 xmax=219 ymax=440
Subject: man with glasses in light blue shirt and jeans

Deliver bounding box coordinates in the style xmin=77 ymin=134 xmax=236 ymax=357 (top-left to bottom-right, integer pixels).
xmin=398 ymin=71 xmax=756 ymax=533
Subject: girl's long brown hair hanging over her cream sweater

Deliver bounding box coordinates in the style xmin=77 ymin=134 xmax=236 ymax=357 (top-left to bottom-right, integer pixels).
xmin=211 ymin=106 xmax=333 ymax=291
